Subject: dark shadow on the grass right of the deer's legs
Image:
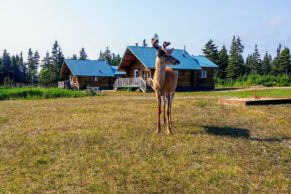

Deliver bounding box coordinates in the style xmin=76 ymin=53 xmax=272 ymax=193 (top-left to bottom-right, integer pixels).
xmin=203 ymin=126 xmax=291 ymax=143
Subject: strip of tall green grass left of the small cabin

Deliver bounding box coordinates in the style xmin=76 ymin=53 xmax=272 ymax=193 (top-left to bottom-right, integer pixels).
xmin=0 ymin=88 xmax=95 ymax=100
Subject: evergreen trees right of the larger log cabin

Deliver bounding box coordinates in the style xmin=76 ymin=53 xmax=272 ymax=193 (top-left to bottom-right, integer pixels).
xmin=202 ymin=36 xmax=291 ymax=82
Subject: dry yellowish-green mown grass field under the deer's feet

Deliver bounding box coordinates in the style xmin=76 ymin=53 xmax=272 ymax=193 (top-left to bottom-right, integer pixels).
xmin=0 ymin=89 xmax=291 ymax=193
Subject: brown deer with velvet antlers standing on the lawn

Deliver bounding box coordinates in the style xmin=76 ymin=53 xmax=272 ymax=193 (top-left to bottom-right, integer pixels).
xmin=152 ymin=38 xmax=180 ymax=135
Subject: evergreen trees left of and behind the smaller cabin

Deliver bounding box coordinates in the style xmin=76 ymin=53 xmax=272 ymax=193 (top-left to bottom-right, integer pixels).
xmin=0 ymin=41 xmax=121 ymax=86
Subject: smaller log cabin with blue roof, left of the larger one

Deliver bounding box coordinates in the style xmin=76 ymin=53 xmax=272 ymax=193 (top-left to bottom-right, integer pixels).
xmin=59 ymin=60 xmax=117 ymax=89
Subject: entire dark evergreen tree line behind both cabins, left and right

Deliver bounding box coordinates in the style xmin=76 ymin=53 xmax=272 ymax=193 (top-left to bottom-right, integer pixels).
xmin=0 ymin=36 xmax=291 ymax=86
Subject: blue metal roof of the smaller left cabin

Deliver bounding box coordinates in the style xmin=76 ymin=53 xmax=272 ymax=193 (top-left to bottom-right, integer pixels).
xmin=64 ymin=59 xmax=114 ymax=77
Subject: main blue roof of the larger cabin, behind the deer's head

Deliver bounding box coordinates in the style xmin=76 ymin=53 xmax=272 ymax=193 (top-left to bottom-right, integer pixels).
xmin=128 ymin=46 xmax=201 ymax=70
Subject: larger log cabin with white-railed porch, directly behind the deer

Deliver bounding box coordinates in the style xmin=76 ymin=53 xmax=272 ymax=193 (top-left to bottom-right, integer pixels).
xmin=113 ymin=46 xmax=218 ymax=92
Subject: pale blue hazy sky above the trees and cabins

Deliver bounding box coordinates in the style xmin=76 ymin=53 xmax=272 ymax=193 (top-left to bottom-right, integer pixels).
xmin=0 ymin=0 xmax=291 ymax=59
